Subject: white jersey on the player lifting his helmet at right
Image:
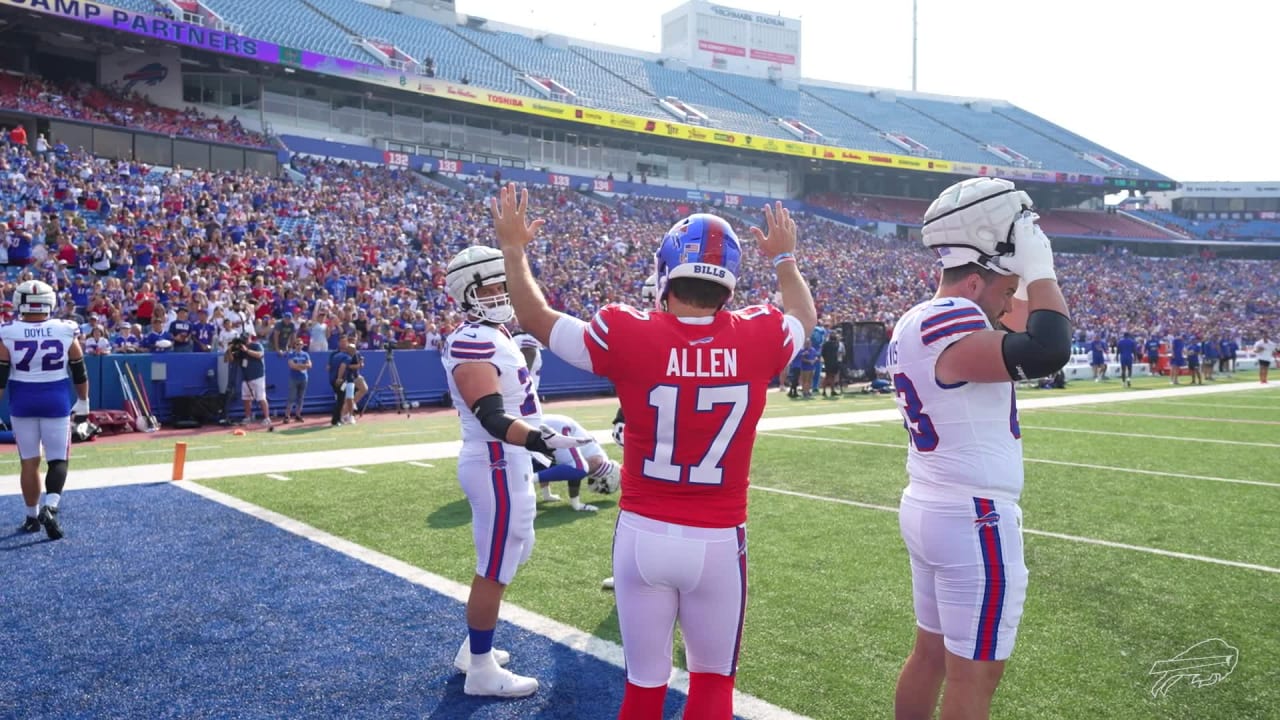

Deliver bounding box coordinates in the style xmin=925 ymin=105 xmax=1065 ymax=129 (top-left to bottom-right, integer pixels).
xmin=888 ymin=297 xmax=1023 ymax=502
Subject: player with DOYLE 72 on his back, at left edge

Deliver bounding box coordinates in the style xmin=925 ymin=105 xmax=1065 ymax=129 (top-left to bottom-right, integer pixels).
xmin=0 ymin=281 xmax=88 ymax=539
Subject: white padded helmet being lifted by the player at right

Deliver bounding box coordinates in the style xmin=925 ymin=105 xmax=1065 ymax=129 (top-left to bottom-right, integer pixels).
xmin=923 ymin=178 xmax=1032 ymax=275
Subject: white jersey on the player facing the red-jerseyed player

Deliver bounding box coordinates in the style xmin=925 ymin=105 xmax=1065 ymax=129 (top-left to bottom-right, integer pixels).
xmin=440 ymin=323 xmax=543 ymax=445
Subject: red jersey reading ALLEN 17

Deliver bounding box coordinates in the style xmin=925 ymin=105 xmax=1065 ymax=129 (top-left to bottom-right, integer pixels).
xmin=584 ymin=299 xmax=803 ymax=528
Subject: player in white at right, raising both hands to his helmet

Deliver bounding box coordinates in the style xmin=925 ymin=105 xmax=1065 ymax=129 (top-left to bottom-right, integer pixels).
xmin=888 ymin=178 xmax=1071 ymax=720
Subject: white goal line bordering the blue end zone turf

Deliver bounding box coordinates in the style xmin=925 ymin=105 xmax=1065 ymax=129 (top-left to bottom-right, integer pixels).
xmin=177 ymin=483 xmax=806 ymax=720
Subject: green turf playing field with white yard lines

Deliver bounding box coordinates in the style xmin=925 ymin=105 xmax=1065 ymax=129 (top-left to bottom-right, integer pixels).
xmin=167 ymin=380 xmax=1280 ymax=720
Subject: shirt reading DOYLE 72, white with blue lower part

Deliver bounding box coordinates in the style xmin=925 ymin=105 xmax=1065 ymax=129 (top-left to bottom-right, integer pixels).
xmin=0 ymin=320 xmax=79 ymax=418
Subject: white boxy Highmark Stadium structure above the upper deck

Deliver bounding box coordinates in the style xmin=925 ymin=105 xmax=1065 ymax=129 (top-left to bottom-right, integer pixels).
xmin=662 ymin=0 xmax=800 ymax=81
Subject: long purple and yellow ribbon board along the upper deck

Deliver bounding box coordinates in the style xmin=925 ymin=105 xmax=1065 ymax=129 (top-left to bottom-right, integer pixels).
xmin=0 ymin=0 xmax=1106 ymax=184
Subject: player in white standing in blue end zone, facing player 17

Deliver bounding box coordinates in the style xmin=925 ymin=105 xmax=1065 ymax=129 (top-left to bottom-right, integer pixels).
xmin=442 ymin=246 xmax=591 ymax=697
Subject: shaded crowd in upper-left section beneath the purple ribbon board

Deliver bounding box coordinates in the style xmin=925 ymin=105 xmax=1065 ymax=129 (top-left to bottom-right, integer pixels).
xmin=0 ymin=73 xmax=273 ymax=147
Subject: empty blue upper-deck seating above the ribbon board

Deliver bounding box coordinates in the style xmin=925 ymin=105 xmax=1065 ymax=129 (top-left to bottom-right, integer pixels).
xmin=142 ymin=0 xmax=1167 ymax=179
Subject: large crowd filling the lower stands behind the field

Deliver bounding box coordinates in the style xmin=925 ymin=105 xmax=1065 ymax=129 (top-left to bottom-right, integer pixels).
xmin=0 ymin=137 xmax=1280 ymax=361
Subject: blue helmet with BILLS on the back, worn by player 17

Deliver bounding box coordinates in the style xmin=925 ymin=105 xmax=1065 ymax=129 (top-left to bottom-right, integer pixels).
xmin=655 ymin=213 xmax=742 ymax=307
